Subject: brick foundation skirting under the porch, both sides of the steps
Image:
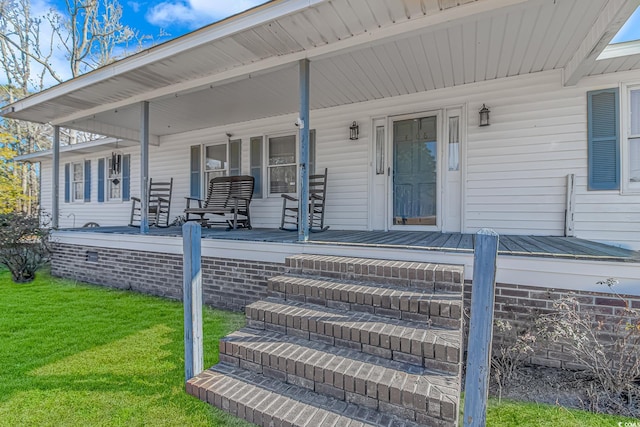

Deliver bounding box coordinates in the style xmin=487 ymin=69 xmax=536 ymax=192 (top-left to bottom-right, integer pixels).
xmin=51 ymin=243 xmax=640 ymax=369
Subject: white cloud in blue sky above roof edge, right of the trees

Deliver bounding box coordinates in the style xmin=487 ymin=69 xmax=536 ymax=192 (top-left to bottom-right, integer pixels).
xmin=146 ymin=0 xmax=265 ymax=29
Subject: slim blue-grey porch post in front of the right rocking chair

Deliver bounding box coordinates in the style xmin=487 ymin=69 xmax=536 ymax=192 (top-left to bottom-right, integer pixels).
xmin=298 ymin=59 xmax=309 ymax=242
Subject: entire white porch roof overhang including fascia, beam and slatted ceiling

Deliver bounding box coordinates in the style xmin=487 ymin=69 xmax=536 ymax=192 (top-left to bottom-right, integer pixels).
xmin=2 ymin=0 xmax=640 ymax=141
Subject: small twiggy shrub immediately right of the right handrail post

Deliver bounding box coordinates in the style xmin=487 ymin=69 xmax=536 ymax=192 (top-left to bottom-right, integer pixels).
xmin=491 ymin=319 xmax=536 ymax=401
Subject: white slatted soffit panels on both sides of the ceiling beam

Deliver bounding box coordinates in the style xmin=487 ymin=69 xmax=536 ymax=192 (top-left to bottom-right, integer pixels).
xmin=2 ymin=0 xmax=616 ymax=139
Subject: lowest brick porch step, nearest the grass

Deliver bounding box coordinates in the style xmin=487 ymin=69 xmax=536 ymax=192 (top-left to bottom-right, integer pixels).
xmin=187 ymin=364 xmax=418 ymax=427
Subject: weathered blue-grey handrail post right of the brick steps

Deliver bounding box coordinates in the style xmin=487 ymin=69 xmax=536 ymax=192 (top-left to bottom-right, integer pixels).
xmin=463 ymin=229 xmax=499 ymax=427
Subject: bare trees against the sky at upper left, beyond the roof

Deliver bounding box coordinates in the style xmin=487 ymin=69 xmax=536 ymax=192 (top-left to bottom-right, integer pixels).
xmin=0 ymin=0 xmax=148 ymax=214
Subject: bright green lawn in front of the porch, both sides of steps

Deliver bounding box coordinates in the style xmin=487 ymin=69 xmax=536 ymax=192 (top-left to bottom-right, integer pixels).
xmin=0 ymin=269 xmax=631 ymax=427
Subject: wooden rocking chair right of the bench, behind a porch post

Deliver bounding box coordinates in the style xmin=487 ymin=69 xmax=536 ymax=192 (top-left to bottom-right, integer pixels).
xmin=280 ymin=168 xmax=329 ymax=233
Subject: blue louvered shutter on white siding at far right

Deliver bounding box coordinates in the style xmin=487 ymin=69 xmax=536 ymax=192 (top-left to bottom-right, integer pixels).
xmin=587 ymin=88 xmax=620 ymax=190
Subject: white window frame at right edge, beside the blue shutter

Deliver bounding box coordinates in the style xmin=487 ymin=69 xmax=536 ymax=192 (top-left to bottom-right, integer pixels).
xmin=620 ymin=83 xmax=640 ymax=195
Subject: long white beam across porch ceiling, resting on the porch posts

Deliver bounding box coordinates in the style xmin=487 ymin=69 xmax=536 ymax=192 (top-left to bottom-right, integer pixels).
xmin=52 ymin=0 xmax=527 ymax=126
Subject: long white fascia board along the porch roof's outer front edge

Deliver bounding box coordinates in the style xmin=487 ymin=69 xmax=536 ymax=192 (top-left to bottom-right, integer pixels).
xmin=8 ymin=0 xmax=328 ymax=115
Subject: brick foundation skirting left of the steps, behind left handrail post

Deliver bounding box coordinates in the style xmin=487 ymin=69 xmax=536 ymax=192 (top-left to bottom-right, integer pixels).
xmin=51 ymin=243 xmax=284 ymax=311
